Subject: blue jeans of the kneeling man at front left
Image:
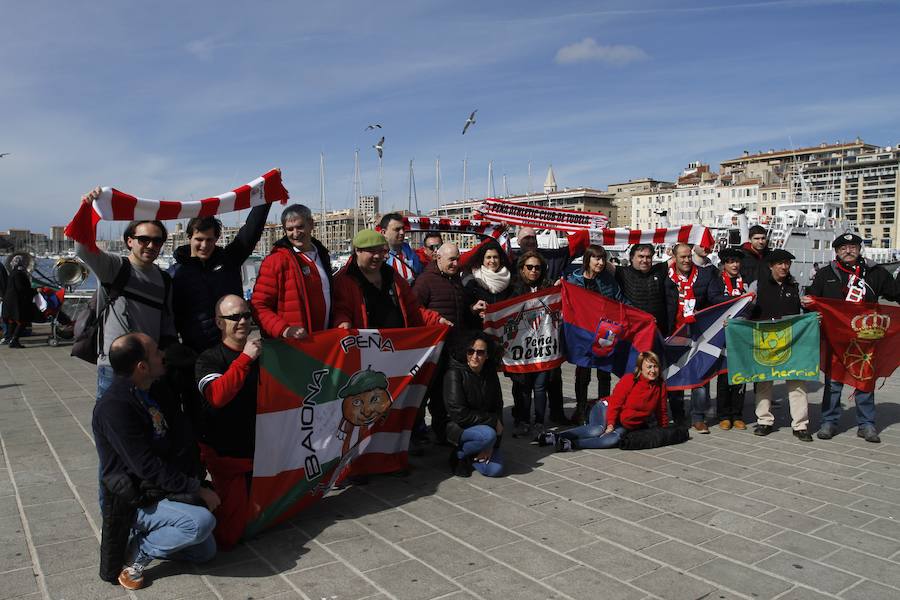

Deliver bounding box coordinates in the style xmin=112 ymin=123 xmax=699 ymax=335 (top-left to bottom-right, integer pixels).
xmin=131 ymin=500 xmax=216 ymax=562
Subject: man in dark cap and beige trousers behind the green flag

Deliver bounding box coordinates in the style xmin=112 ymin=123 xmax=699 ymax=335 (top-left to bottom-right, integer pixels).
xmin=753 ymin=248 xmax=812 ymax=442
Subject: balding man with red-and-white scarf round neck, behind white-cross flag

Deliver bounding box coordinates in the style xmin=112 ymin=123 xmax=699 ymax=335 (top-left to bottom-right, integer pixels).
xmin=665 ymin=243 xmax=716 ymax=433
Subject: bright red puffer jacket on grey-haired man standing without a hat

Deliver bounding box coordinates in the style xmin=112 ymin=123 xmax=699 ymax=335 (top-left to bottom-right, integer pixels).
xmin=250 ymin=239 xmax=331 ymax=338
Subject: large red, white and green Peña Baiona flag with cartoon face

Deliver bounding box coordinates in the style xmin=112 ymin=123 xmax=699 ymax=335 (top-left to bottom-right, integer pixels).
xmin=245 ymin=327 xmax=447 ymax=535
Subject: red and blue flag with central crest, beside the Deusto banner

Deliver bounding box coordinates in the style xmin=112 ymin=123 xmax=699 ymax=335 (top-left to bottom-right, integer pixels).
xmin=562 ymin=282 xmax=662 ymax=377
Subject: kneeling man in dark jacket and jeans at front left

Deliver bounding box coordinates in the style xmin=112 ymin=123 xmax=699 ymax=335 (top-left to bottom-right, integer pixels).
xmin=92 ymin=333 xmax=219 ymax=590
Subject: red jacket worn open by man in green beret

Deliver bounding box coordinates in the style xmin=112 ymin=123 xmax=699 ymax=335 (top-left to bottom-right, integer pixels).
xmin=331 ymin=260 xmax=441 ymax=329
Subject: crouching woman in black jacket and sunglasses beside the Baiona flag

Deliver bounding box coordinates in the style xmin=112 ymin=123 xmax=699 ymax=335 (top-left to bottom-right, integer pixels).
xmin=444 ymin=332 xmax=503 ymax=477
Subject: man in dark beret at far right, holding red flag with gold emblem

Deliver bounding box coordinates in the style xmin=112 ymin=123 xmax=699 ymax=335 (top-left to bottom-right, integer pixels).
xmin=803 ymin=233 xmax=898 ymax=444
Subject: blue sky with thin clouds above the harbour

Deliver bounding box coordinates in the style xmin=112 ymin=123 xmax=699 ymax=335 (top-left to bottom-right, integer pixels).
xmin=0 ymin=0 xmax=900 ymax=231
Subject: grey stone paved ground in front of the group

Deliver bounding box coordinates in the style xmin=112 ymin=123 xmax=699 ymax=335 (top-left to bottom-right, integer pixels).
xmin=0 ymin=328 xmax=900 ymax=600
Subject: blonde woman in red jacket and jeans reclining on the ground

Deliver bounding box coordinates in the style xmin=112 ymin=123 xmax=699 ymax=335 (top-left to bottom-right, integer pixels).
xmin=538 ymin=352 xmax=669 ymax=452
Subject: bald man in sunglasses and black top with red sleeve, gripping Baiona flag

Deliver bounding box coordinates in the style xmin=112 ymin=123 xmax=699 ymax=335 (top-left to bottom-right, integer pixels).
xmin=194 ymin=294 xmax=262 ymax=550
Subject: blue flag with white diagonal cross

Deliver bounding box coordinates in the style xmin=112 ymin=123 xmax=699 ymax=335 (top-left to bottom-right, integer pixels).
xmin=665 ymin=294 xmax=753 ymax=390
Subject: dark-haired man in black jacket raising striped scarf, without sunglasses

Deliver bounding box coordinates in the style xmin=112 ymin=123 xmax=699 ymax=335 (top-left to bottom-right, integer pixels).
xmin=171 ymin=204 xmax=272 ymax=353
